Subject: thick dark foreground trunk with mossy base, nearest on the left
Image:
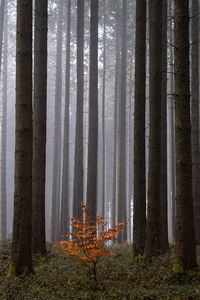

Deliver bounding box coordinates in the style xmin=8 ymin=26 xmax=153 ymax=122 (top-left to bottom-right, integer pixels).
xmin=9 ymin=0 xmax=33 ymax=276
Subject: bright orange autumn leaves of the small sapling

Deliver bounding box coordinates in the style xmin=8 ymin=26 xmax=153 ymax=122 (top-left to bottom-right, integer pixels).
xmin=56 ymin=205 xmax=125 ymax=265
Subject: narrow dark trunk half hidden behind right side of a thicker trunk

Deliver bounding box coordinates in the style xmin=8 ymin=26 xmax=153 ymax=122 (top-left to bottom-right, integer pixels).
xmin=161 ymin=0 xmax=169 ymax=253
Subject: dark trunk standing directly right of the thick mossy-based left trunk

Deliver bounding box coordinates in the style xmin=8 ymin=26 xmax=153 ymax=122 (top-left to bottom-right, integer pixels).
xmin=32 ymin=0 xmax=48 ymax=255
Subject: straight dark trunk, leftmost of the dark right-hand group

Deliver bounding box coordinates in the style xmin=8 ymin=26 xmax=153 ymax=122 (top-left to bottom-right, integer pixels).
xmin=133 ymin=0 xmax=146 ymax=254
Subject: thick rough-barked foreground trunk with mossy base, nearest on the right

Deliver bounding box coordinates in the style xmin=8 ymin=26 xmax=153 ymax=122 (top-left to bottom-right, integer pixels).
xmin=174 ymin=0 xmax=196 ymax=268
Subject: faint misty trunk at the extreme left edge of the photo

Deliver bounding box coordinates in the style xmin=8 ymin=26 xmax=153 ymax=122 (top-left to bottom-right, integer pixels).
xmin=0 ymin=1 xmax=8 ymax=240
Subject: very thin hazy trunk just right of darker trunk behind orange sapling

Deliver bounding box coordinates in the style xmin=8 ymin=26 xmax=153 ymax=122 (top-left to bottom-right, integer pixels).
xmin=102 ymin=2 xmax=106 ymax=218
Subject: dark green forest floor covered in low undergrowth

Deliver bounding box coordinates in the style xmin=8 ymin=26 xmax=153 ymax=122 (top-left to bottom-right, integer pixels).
xmin=0 ymin=241 xmax=200 ymax=300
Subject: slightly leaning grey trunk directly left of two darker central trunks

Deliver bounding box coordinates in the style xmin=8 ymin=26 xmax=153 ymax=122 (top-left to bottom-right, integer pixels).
xmin=61 ymin=0 xmax=71 ymax=235
